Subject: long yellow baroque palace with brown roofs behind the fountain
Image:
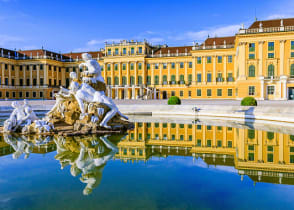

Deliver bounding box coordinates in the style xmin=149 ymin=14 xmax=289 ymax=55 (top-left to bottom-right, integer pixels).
xmin=0 ymin=18 xmax=294 ymax=100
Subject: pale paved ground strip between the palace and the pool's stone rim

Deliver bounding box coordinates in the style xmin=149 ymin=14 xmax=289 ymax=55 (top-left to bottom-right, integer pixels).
xmin=0 ymin=99 xmax=294 ymax=107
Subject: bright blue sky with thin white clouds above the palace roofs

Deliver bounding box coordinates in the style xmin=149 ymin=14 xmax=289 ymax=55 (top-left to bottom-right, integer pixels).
xmin=0 ymin=0 xmax=294 ymax=53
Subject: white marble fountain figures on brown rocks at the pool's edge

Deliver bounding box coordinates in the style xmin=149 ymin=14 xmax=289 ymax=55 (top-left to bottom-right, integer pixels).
xmin=3 ymin=53 xmax=133 ymax=135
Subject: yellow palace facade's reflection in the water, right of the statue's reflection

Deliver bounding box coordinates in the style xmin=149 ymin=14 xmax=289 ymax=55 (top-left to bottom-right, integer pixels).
xmin=115 ymin=122 xmax=294 ymax=184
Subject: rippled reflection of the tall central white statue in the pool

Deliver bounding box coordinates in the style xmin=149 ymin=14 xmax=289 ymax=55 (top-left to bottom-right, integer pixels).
xmin=55 ymin=136 xmax=118 ymax=195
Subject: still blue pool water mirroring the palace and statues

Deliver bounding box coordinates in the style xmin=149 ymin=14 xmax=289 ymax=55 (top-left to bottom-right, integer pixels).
xmin=0 ymin=117 xmax=294 ymax=209
